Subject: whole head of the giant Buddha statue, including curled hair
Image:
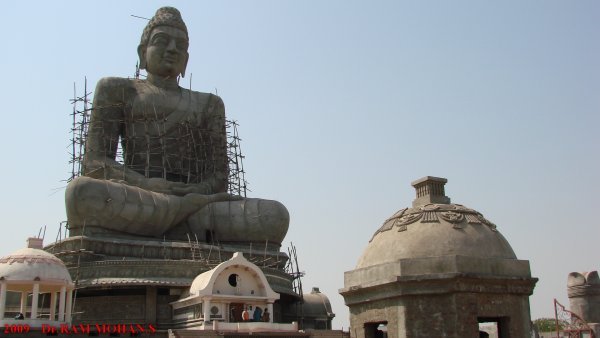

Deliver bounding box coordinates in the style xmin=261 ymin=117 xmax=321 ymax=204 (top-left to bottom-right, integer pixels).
xmin=138 ymin=7 xmax=189 ymax=77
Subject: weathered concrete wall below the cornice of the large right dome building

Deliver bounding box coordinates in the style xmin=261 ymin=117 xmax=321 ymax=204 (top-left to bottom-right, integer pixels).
xmin=350 ymin=293 xmax=530 ymax=338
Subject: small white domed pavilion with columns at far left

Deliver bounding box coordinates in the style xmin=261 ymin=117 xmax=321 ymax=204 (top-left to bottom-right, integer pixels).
xmin=0 ymin=238 xmax=74 ymax=329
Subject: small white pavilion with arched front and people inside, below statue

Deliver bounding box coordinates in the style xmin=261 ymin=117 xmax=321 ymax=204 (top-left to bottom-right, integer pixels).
xmin=171 ymin=252 xmax=298 ymax=332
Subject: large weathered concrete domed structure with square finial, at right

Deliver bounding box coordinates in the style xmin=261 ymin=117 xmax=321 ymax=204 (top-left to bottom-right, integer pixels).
xmin=340 ymin=176 xmax=537 ymax=338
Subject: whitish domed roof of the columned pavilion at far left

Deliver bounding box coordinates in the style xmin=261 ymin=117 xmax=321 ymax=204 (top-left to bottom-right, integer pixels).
xmin=0 ymin=238 xmax=71 ymax=284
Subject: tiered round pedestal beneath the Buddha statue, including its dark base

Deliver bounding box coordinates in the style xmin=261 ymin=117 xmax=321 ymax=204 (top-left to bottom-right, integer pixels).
xmin=45 ymin=236 xmax=296 ymax=329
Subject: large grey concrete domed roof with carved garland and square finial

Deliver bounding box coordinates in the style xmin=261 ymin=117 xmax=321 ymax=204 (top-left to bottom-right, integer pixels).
xmin=356 ymin=176 xmax=516 ymax=269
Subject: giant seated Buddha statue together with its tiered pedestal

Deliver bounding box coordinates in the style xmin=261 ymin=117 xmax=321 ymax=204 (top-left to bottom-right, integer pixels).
xmin=45 ymin=7 xmax=298 ymax=329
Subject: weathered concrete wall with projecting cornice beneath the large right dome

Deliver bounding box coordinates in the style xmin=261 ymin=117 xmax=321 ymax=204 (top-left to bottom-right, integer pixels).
xmin=342 ymin=275 xmax=536 ymax=338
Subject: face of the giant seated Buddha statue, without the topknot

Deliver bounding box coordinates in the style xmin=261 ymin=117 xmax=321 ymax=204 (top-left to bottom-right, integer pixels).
xmin=141 ymin=26 xmax=189 ymax=78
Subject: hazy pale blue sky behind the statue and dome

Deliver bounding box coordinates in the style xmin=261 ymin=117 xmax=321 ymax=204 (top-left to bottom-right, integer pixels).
xmin=0 ymin=0 xmax=600 ymax=328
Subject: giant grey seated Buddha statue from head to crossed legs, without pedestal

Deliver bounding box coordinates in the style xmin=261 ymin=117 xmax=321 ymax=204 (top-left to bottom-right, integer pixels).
xmin=66 ymin=7 xmax=289 ymax=244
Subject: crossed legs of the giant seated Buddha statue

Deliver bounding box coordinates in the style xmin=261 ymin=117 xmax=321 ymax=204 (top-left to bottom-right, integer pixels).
xmin=65 ymin=176 xmax=289 ymax=243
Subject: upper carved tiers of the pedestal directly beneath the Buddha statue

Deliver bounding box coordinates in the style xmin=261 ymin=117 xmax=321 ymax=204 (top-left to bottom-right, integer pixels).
xmin=46 ymin=237 xmax=293 ymax=294
